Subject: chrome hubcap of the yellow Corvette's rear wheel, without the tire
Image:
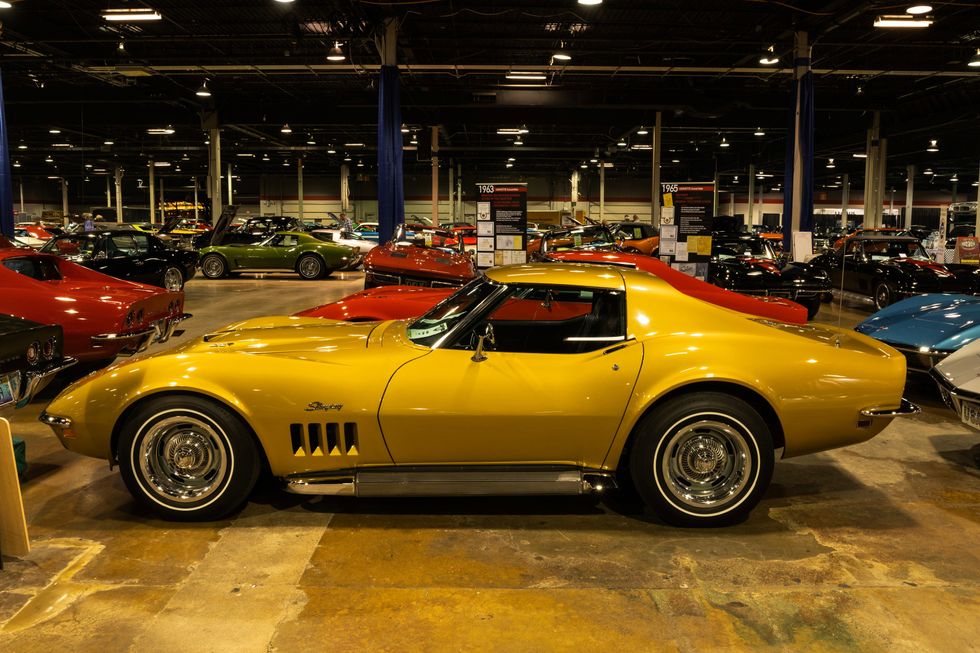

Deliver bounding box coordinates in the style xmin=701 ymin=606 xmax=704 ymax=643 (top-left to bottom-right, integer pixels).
xmin=661 ymin=420 xmax=752 ymax=508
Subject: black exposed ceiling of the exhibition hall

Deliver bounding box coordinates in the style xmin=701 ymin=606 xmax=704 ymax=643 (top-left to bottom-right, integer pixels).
xmin=0 ymin=0 xmax=980 ymax=191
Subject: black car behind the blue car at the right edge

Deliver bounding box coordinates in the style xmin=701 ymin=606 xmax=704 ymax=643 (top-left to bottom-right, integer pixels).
xmin=810 ymin=233 xmax=980 ymax=310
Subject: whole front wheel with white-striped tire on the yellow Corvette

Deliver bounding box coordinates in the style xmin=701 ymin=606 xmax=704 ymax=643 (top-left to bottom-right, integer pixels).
xmin=116 ymin=395 xmax=261 ymax=521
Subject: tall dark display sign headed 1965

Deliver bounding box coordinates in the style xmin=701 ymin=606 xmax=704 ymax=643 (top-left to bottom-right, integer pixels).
xmin=660 ymin=181 xmax=715 ymax=280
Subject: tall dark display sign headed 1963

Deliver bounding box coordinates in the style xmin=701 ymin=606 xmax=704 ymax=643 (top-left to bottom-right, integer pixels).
xmin=476 ymin=184 xmax=527 ymax=268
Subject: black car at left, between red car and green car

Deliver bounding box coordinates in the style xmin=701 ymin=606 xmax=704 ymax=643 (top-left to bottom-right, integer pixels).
xmin=41 ymin=229 xmax=197 ymax=291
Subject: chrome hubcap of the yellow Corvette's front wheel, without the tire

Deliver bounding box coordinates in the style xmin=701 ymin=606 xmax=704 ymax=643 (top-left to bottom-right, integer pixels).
xmin=139 ymin=416 xmax=228 ymax=503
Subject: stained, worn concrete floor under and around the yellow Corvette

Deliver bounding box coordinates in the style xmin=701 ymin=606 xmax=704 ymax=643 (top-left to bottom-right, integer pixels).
xmin=0 ymin=273 xmax=980 ymax=653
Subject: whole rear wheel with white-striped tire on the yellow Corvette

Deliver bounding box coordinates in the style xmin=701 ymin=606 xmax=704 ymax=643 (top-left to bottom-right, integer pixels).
xmin=629 ymin=392 xmax=774 ymax=526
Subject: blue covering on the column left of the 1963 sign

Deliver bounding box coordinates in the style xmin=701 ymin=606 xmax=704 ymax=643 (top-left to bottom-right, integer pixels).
xmin=378 ymin=65 xmax=405 ymax=244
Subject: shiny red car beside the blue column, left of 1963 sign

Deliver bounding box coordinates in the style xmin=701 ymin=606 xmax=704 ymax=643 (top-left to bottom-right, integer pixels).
xmin=364 ymin=226 xmax=477 ymax=288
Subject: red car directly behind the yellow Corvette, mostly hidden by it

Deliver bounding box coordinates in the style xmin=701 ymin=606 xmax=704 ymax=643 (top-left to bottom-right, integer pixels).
xmin=296 ymin=250 xmax=807 ymax=324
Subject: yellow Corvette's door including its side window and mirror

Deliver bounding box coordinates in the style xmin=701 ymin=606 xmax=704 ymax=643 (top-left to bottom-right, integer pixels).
xmin=379 ymin=287 xmax=643 ymax=465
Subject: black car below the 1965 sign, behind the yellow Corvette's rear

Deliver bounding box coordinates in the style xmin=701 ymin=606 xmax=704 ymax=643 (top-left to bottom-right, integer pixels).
xmin=708 ymin=233 xmax=832 ymax=320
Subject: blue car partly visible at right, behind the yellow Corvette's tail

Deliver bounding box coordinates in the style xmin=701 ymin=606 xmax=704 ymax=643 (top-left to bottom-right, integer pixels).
xmin=855 ymin=294 xmax=980 ymax=372
